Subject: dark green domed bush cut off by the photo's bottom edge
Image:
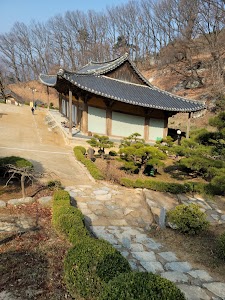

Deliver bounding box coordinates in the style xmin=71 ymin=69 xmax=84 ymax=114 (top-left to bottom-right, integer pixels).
xmin=99 ymin=272 xmax=185 ymax=300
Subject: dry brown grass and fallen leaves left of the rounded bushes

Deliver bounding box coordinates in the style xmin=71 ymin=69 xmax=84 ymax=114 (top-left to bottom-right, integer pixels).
xmin=0 ymin=203 xmax=71 ymax=300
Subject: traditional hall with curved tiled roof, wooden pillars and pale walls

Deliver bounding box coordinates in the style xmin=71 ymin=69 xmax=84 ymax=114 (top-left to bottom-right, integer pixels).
xmin=39 ymin=54 xmax=205 ymax=142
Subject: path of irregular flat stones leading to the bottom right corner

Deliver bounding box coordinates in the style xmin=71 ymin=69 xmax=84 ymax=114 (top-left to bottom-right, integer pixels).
xmin=66 ymin=184 xmax=225 ymax=300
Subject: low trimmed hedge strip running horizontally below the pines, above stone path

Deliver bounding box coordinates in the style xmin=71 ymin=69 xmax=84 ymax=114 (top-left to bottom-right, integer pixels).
xmin=120 ymin=178 xmax=191 ymax=194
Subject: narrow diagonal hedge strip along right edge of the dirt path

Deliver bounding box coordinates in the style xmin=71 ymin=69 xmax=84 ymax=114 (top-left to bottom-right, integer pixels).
xmin=73 ymin=146 xmax=104 ymax=180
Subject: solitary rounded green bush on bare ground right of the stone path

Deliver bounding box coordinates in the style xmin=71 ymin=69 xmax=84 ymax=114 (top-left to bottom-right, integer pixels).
xmin=167 ymin=203 xmax=209 ymax=235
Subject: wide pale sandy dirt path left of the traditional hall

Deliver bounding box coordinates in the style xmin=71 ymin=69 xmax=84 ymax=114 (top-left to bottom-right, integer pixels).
xmin=0 ymin=104 xmax=92 ymax=186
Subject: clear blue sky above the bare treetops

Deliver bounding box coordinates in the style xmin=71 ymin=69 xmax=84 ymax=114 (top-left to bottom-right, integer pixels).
xmin=0 ymin=0 xmax=129 ymax=34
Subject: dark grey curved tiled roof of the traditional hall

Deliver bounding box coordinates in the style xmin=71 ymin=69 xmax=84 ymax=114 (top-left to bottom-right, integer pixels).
xmin=39 ymin=54 xmax=205 ymax=112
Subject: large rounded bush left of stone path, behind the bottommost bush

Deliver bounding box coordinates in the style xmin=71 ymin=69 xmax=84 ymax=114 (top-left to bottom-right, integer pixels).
xmin=64 ymin=238 xmax=130 ymax=299
